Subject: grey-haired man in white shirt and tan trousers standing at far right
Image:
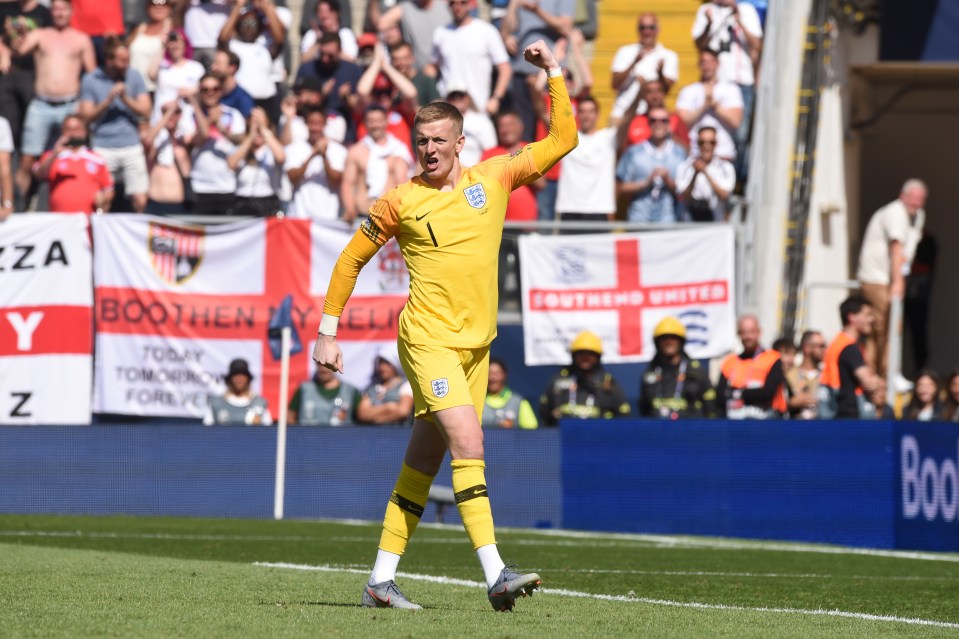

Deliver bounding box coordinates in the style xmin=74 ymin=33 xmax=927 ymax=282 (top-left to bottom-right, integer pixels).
xmin=856 ymin=179 xmax=928 ymax=378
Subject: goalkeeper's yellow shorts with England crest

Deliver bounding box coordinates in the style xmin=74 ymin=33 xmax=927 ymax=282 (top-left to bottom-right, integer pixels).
xmin=398 ymin=340 xmax=489 ymax=421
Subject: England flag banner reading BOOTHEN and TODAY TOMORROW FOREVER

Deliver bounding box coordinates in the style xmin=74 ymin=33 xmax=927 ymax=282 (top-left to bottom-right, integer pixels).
xmin=93 ymin=215 xmax=409 ymax=417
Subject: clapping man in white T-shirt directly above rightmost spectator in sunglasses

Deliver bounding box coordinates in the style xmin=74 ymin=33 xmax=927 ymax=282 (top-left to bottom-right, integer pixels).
xmin=676 ymin=49 xmax=743 ymax=161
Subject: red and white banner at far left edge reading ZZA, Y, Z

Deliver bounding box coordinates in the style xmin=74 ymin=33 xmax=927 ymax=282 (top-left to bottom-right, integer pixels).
xmin=0 ymin=213 xmax=93 ymax=424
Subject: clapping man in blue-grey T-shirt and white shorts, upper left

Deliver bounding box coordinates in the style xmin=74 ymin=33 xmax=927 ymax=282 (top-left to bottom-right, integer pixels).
xmin=79 ymin=37 xmax=151 ymax=213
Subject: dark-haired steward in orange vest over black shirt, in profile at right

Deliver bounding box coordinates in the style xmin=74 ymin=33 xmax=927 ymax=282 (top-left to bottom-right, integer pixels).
xmin=819 ymin=295 xmax=886 ymax=419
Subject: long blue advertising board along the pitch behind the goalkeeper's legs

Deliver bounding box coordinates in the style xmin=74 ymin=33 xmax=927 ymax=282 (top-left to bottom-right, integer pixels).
xmin=0 ymin=420 xmax=959 ymax=551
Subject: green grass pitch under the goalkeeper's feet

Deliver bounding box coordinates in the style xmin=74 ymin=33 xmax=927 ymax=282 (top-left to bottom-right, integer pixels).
xmin=0 ymin=515 xmax=959 ymax=639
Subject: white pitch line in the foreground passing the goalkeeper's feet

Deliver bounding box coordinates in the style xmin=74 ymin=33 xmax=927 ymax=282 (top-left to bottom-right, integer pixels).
xmin=253 ymin=561 xmax=959 ymax=628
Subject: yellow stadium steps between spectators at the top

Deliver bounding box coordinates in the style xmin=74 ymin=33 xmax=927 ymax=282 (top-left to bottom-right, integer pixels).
xmin=590 ymin=0 xmax=702 ymax=114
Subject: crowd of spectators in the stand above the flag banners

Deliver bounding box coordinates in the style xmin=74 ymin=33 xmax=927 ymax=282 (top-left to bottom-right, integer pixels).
xmin=0 ymin=0 xmax=762 ymax=222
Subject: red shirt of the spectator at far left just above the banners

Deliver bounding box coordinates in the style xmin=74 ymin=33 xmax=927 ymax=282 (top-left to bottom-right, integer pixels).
xmin=37 ymin=147 xmax=113 ymax=213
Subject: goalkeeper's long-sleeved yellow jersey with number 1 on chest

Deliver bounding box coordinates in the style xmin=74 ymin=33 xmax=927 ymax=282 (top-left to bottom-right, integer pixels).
xmin=323 ymin=78 xmax=577 ymax=348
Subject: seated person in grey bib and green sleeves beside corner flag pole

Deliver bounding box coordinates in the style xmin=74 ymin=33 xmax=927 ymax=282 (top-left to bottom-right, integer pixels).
xmin=289 ymin=366 xmax=360 ymax=426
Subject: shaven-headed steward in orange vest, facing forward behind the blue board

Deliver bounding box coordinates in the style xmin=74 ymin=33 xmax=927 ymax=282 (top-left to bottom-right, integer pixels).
xmin=716 ymin=315 xmax=788 ymax=419
